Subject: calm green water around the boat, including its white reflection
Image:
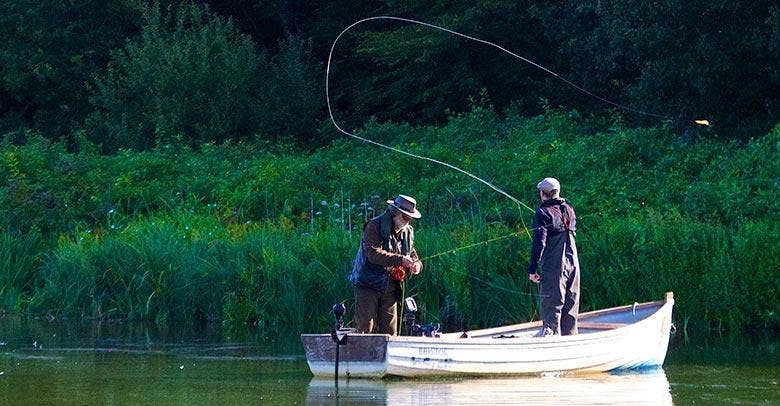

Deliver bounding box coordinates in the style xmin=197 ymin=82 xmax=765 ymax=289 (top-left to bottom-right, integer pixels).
xmin=0 ymin=316 xmax=780 ymax=405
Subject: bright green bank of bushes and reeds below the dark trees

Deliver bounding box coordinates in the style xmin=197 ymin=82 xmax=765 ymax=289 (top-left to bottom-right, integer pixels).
xmin=0 ymin=108 xmax=780 ymax=332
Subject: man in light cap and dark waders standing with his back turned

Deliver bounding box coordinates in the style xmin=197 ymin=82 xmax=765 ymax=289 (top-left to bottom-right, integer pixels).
xmin=528 ymin=178 xmax=580 ymax=336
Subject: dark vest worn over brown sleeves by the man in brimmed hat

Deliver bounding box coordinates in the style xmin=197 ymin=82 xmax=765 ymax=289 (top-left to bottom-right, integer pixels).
xmin=348 ymin=211 xmax=414 ymax=292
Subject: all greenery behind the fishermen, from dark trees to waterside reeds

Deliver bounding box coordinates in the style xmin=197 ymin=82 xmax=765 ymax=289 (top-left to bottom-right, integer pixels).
xmin=0 ymin=0 xmax=780 ymax=333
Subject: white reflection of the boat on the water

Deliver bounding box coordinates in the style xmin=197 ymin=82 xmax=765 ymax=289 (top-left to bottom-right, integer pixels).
xmin=306 ymin=368 xmax=672 ymax=406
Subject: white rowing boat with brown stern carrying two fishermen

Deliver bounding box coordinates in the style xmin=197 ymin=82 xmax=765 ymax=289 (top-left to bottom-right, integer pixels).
xmin=301 ymin=292 xmax=674 ymax=378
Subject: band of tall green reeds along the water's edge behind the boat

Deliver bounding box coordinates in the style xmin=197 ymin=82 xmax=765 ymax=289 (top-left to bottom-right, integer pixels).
xmin=5 ymin=195 xmax=778 ymax=334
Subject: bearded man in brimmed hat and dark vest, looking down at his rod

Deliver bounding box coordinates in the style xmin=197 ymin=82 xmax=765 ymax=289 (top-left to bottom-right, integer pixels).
xmin=349 ymin=195 xmax=422 ymax=335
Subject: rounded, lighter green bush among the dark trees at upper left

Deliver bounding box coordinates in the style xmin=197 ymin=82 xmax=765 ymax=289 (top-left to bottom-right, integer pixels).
xmin=89 ymin=2 xmax=262 ymax=150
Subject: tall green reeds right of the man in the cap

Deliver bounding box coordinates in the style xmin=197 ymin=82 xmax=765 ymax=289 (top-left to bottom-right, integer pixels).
xmin=579 ymin=217 xmax=780 ymax=330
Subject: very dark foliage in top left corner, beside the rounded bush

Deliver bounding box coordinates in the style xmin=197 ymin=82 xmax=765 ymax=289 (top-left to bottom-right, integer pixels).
xmin=0 ymin=0 xmax=139 ymax=139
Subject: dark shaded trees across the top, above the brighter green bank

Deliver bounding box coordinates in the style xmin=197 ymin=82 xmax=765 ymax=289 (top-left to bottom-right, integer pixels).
xmin=0 ymin=0 xmax=780 ymax=144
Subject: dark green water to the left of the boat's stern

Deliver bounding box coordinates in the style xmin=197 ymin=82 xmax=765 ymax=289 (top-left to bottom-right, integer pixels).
xmin=0 ymin=315 xmax=309 ymax=406
